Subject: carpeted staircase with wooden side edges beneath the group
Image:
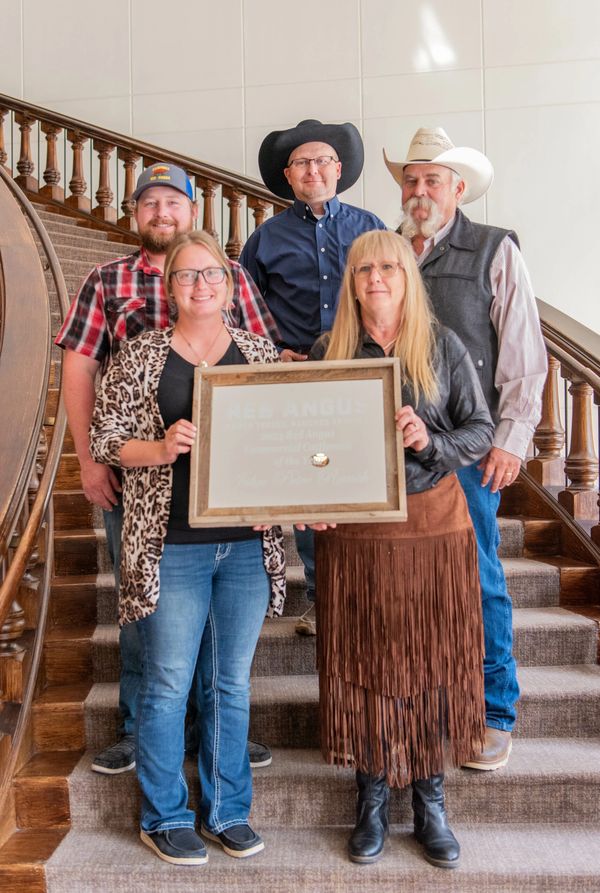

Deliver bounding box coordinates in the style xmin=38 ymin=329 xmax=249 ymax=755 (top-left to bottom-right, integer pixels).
xmin=0 ymin=210 xmax=600 ymax=893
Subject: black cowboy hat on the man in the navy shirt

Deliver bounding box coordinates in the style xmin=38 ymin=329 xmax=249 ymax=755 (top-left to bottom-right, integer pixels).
xmin=258 ymin=119 xmax=365 ymax=198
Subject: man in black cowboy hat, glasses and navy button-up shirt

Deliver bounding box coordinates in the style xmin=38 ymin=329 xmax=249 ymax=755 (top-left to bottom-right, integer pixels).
xmin=240 ymin=119 xmax=386 ymax=635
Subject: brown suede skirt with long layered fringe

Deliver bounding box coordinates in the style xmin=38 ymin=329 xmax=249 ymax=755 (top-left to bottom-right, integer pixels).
xmin=316 ymin=475 xmax=485 ymax=787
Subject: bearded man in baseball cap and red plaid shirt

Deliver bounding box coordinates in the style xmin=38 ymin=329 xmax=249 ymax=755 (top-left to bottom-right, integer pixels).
xmin=56 ymin=162 xmax=279 ymax=775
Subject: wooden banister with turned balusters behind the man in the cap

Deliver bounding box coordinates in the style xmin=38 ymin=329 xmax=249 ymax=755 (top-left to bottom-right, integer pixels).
xmin=0 ymin=94 xmax=289 ymax=259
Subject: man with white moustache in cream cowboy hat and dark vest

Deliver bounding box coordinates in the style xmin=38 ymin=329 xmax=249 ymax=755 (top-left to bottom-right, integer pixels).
xmin=383 ymin=127 xmax=546 ymax=770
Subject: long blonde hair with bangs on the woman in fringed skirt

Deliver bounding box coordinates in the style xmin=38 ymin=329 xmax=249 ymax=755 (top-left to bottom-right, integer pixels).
xmin=324 ymin=230 xmax=439 ymax=402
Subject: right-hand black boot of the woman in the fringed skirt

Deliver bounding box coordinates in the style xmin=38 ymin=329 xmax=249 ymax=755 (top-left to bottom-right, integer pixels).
xmin=412 ymin=775 xmax=460 ymax=868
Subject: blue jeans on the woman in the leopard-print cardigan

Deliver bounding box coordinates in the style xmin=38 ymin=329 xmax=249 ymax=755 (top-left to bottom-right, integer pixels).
xmin=136 ymin=537 xmax=269 ymax=834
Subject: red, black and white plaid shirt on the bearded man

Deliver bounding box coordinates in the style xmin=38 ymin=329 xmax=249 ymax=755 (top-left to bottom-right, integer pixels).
xmin=55 ymin=248 xmax=279 ymax=371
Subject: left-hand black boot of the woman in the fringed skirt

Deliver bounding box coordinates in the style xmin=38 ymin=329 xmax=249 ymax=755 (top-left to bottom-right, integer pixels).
xmin=348 ymin=772 xmax=390 ymax=862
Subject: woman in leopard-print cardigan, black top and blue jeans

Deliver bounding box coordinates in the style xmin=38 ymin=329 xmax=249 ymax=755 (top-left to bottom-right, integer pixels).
xmin=90 ymin=232 xmax=285 ymax=864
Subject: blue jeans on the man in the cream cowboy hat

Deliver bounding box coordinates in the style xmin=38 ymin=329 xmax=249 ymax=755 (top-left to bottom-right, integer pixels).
xmin=458 ymin=465 xmax=519 ymax=731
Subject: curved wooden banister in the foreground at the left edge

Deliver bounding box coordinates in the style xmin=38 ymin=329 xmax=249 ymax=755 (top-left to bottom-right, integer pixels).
xmin=0 ymin=167 xmax=69 ymax=836
